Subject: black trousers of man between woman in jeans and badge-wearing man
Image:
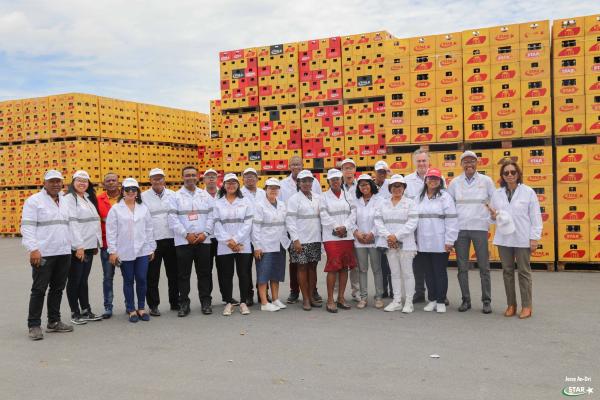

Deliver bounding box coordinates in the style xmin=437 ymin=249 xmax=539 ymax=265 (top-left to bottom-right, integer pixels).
xmin=146 ymin=239 xmax=179 ymax=308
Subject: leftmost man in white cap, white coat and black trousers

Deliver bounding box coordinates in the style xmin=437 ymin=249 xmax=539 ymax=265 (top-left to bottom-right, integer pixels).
xmin=21 ymin=169 xmax=73 ymax=340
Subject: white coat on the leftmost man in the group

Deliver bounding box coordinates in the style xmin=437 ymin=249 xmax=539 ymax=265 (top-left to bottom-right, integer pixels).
xmin=21 ymin=189 xmax=71 ymax=257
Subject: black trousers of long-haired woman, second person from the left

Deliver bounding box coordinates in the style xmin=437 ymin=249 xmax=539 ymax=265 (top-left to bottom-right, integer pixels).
xmin=67 ymin=249 xmax=94 ymax=314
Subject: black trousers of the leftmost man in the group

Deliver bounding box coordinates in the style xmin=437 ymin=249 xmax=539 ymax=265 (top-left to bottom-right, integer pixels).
xmin=27 ymin=254 xmax=71 ymax=328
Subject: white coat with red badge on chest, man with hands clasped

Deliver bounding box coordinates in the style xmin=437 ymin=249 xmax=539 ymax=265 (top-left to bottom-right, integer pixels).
xmin=168 ymin=187 xmax=215 ymax=246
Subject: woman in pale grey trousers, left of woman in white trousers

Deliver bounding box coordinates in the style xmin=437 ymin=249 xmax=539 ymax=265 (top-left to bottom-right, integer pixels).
xmin=354 ymin=174 xmax=383 ymax=308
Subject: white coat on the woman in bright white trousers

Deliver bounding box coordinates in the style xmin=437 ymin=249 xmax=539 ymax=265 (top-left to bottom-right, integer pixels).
xmin=374 ymin=196 xmax=419 ymax=251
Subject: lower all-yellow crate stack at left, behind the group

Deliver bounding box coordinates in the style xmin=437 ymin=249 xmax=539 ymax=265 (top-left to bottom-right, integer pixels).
xmin=0 ymin=93 xmax=209 ymax=234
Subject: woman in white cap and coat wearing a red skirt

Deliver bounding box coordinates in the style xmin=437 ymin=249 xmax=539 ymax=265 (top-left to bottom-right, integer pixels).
xmin=324 ymin=168 xmax=357 ymax=313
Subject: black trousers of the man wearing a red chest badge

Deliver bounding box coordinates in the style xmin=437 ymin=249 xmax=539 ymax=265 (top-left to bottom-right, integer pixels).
xmin=176 ymin=243 xmax=212 ymax=306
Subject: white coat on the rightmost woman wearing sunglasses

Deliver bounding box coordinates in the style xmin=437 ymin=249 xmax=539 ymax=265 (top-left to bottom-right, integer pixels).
xmin=491 ymin=184 xmax=543 ymax=248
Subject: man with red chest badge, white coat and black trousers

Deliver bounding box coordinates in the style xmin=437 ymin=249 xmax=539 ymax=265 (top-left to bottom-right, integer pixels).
xmin=168 ymin=166 xmax=215 ymax=317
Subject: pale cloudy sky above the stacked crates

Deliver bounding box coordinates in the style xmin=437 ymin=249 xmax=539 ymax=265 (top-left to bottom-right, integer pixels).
xmin=0 ymin=0 xmax=600 ymax=113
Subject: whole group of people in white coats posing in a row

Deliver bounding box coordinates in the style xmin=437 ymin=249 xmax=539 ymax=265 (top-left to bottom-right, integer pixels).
xmin=21 ymin=150 xmax=542 ymax=340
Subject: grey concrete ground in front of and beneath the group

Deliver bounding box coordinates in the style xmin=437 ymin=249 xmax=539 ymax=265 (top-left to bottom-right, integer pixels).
xmin=0 ymin=239 xmax=600 ymax=400
